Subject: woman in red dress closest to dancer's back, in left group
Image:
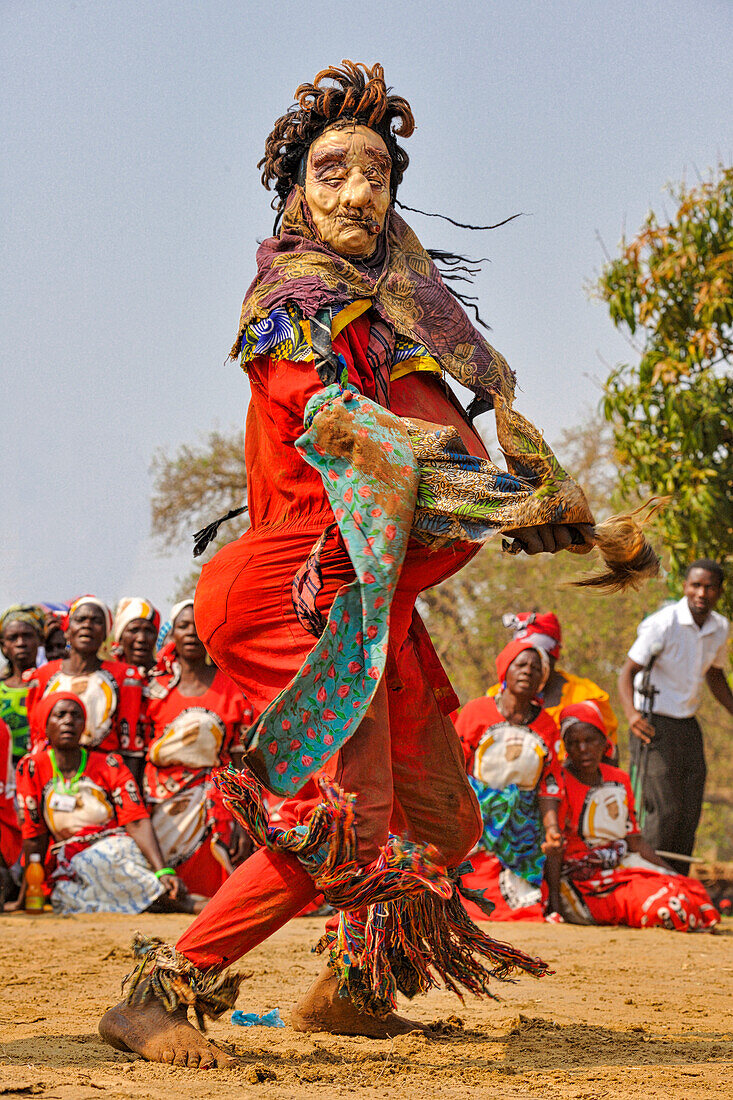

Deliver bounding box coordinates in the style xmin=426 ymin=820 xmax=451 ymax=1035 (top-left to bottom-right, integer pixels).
xmin=143 ymin=600 xmax=252 ymax=898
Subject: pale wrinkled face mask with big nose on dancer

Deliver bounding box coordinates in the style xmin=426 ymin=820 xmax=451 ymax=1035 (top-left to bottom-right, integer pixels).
xmin=305 ymin=124 xmax=392 ymax=256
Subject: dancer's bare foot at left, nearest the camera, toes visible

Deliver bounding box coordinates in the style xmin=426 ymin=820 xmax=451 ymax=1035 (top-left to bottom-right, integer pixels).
xmin=99 ymin=993 xmax=237 ymax=1069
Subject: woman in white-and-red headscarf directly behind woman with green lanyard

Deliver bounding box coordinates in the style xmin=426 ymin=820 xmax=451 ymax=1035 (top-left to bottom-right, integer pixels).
xmin=23 ymin=595 xmax=143 ymax=758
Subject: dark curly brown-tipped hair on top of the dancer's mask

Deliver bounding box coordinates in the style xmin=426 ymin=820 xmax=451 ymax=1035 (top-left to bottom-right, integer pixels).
xmin=258 ymin=59 xmax=415 ymax=218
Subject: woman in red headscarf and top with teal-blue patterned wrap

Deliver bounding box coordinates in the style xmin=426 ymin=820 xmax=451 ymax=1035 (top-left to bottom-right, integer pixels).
xmin=456 ymin=638 xmax=562 ymax=921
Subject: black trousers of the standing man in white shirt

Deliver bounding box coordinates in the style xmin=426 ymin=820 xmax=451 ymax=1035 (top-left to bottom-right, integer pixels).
xmin=631 ymin=714 xmax=707 ymax=875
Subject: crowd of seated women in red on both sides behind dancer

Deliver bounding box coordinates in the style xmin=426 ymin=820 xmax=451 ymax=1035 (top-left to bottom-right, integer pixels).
xmin=0 ymin=595 xmax=719 ymax=931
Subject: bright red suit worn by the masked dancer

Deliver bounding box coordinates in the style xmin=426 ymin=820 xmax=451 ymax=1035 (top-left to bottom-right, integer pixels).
xmin=177 ymin=310 xmax=485 ymax=967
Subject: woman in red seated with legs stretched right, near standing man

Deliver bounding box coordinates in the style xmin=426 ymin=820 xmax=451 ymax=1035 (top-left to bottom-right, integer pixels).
xmin=560 ymin=701 xmax=720 ymax=932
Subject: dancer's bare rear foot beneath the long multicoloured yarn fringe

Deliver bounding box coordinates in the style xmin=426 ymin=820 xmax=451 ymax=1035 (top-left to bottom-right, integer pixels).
xmin=291 ymin=965 xmax=430 ymax=1038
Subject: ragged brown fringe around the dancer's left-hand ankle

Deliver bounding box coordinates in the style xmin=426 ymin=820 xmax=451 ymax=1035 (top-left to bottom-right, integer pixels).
xmin=122 ymin=932 xmax=244 ymax=1031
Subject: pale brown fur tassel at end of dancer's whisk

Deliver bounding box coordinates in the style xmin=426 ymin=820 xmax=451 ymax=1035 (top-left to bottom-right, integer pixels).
xmin=570 ymin=496 xmax=670 ymax=592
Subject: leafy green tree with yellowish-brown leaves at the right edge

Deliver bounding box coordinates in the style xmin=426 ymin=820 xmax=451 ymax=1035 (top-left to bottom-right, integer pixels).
xmin=595 ymin=167 xmax=733 ymax=614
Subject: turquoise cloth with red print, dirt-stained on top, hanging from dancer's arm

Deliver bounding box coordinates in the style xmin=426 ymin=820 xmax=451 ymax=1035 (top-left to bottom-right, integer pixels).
xmin=234 ymin=384 xmax=419 ymax=794
